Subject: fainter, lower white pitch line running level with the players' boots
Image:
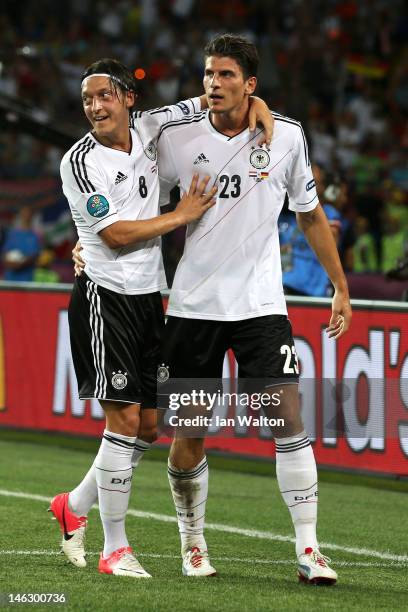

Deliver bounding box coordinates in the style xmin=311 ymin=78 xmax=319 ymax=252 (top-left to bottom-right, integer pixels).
xmin=0 ymin=550 xmax=407 ymax=569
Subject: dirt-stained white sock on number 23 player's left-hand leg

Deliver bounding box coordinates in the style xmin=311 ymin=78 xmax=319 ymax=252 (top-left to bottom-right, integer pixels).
xmin=168 ymin=457 xmax=208 ymax=555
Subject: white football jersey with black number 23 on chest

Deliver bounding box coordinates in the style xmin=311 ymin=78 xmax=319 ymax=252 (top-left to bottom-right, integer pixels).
xmin=158 ymin=111 xmax=318 ymax=321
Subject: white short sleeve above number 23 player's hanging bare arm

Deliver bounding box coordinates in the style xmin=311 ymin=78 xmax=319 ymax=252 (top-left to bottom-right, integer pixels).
xmin=287 ymin=124 xmax=319 ymax=212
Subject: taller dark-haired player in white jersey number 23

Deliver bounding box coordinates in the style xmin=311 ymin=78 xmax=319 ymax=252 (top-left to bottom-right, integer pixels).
xmin=158 ymin=34 xmax=351 ymax=584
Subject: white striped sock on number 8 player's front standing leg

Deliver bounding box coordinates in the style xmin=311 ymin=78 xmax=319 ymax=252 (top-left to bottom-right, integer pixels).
xmin=95 ymin=429 xmax=136 ymax=557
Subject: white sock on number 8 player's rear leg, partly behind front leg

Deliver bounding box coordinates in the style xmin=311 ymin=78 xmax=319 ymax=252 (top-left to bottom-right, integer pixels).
xmin=68 ymin=438 xmax=151 ymax=516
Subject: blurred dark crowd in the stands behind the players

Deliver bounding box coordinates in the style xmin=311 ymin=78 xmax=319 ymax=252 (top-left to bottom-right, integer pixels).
xmin=0 ymin=0 xmax=408 ymax=299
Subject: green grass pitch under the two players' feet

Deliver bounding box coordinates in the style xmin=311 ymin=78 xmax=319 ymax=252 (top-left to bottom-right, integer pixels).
xmin=0 ymin=439 xmax=408 ymax=612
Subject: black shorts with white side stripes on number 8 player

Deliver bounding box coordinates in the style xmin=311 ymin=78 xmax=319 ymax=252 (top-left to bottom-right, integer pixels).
xmin=68 ymin=273 xmax=164 ymax=408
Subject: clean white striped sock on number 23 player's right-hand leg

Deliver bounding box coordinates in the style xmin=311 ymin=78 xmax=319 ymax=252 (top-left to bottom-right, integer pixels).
xmin=275 ymin=431 xmax=317 ymax=555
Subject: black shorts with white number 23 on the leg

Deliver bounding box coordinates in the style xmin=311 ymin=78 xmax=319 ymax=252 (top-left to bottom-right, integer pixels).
xmin=163 ymin=315 xmax=299 ymax=390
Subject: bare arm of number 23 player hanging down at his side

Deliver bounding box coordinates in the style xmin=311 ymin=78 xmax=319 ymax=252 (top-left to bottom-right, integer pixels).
xmin=296 ymin=204 xmax=352 ymax=339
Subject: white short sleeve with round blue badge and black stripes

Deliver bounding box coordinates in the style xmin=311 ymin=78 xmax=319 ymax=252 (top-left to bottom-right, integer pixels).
xmin=60 ymin=154 xmax=119 ymax=234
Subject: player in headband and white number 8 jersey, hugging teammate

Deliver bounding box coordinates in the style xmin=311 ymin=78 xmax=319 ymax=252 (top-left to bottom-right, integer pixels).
xmin=50 ymin=59 xmax=271 ymax=578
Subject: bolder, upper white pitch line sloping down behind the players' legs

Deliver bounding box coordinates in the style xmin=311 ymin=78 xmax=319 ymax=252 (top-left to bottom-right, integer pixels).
xmin=0 ymin=489 xmax=408 ymax=563
